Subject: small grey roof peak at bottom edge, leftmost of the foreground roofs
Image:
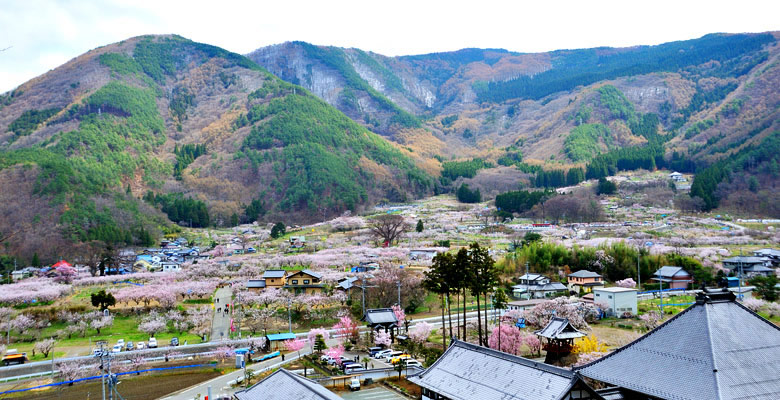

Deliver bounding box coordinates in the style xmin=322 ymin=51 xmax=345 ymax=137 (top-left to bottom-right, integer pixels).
xmin=233 ymin=368 xmax=341 ymax=400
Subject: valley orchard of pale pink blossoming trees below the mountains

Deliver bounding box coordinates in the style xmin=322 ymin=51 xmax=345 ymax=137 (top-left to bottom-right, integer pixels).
xmin=0 ymin=191 xmax=780 ymax=372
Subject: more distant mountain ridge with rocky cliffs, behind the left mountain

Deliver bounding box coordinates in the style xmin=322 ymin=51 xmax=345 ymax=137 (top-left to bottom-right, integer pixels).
xmin=247 ymin=32 xmax=780 ymax=167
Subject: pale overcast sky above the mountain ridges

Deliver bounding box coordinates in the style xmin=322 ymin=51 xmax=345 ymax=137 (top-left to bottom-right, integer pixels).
xmin=0 ymin=0 xmax=780 ymax=92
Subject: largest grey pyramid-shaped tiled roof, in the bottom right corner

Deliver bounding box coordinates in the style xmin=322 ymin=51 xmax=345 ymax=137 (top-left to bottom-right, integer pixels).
xmin=576 ymin=294 xmax=780 ymax=400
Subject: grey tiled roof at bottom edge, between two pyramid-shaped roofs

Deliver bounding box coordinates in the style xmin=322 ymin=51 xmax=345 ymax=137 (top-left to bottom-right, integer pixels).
xmin=409 ymin=340 xmax=577 ymax=400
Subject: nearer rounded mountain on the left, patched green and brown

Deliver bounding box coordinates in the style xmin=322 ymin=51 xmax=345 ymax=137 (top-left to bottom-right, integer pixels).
xmin=0 ymin=36 xmax=432 ymax=260
